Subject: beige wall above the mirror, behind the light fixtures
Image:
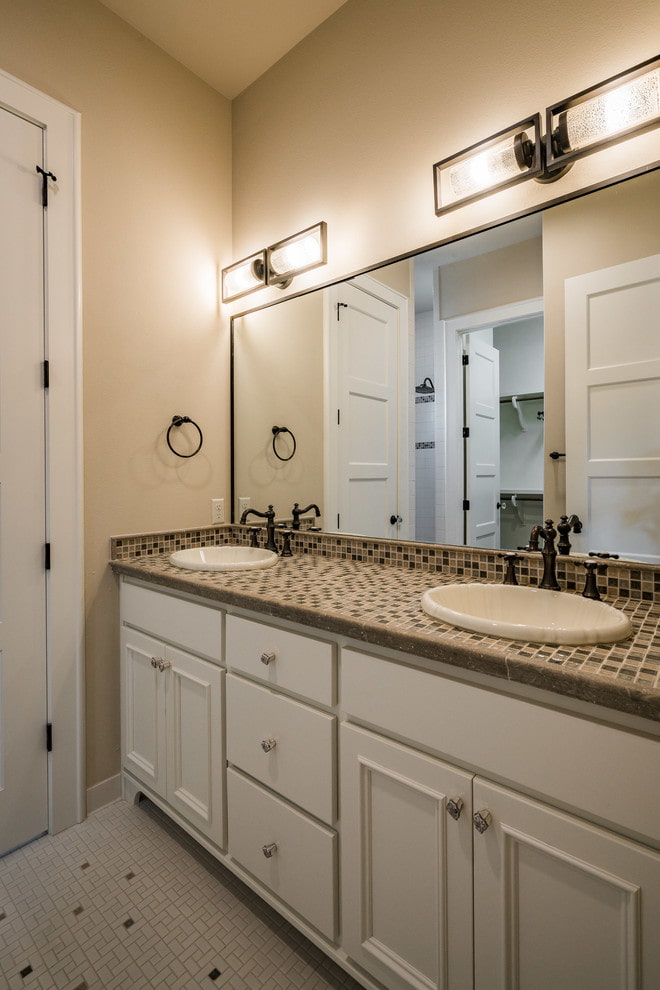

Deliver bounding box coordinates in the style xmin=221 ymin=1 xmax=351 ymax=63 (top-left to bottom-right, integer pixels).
xmin=233 ymin=0 xmax=660 ymax=301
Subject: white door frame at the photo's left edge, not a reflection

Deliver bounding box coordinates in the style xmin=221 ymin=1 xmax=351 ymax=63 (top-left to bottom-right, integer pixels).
xmin=0 ymin=70 xmax=85 ymax=832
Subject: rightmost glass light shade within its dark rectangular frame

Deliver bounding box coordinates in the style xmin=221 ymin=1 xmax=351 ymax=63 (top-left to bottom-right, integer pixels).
xmin=546 ymin=59 xmax=660 ymax=162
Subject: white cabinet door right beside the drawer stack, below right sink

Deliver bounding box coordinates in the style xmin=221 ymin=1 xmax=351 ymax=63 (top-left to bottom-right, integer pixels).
xmin=340 ymin=725 xmax=472 ymax=990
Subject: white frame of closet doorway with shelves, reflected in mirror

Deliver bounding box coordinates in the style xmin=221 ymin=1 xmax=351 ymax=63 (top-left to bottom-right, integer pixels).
xmin=440 ymin=296 xmax=544 ymax=546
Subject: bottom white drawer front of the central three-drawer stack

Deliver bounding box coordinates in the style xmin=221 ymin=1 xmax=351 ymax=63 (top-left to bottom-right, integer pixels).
xmin=227 ymin=768 xmax=337 ymax=942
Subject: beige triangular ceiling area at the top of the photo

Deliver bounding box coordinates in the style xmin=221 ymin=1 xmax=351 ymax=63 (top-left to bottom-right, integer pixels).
xmin=102 ymin=0 xmax=346 ymax=100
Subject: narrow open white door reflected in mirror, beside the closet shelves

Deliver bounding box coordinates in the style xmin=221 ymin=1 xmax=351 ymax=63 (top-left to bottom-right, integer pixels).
xmin=465 ymin=334 xmax=500 ymax=548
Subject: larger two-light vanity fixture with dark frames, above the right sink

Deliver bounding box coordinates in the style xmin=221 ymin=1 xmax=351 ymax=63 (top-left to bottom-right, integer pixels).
xmin=433 ymin=56 xmax=660 ymax=216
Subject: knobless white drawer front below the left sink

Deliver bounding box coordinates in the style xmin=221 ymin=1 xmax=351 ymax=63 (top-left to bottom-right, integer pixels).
xmin=121 ymin=581 xmax=224 ymax=661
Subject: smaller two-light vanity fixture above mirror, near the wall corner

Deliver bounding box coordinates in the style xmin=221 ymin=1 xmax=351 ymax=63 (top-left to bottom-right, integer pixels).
xmin=222 ymin=221 xmax=328 ymax=302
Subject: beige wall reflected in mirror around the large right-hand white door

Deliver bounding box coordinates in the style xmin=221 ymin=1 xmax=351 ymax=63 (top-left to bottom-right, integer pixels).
xmin=543 ymin=172 xmax=660 ymax=519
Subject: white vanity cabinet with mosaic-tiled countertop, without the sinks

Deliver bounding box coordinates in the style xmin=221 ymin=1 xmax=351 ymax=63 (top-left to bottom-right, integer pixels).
xmin=112 ymin=546 xmax=660 ymax=990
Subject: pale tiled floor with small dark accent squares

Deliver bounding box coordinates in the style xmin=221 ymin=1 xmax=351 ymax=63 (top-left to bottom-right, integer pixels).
xmin=0 ymin=801 xmax=358 ymax=990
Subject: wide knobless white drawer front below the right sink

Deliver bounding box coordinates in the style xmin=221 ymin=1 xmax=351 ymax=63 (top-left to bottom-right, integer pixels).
xmin=341 ymin=649 xmax=660 ymax=844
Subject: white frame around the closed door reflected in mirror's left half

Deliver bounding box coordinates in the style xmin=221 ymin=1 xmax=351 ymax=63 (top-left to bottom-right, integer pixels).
xmin=323 ymin=275 xmax=410 ymax=540
